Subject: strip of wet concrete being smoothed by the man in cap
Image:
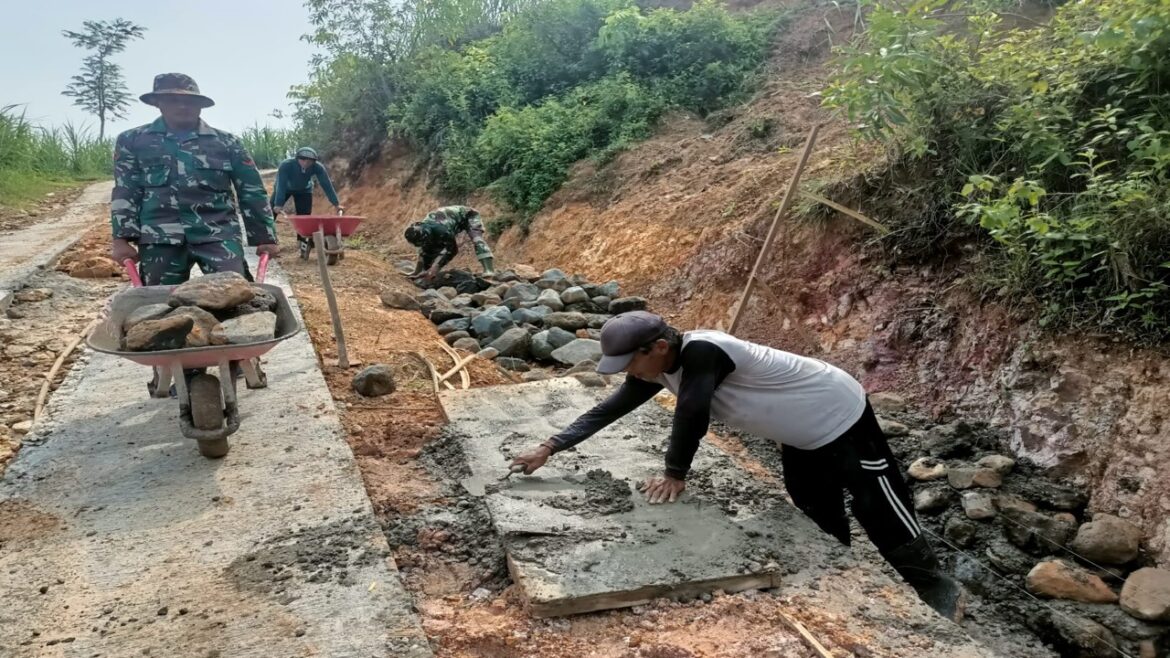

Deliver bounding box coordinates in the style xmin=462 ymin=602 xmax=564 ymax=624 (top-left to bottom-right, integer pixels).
xmin=442 ymin=378 xmax=991 ymax=656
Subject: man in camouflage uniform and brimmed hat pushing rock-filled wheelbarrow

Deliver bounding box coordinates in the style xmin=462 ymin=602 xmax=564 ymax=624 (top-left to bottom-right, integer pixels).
xmin=110 ymin=73 xmax=278 ymax=286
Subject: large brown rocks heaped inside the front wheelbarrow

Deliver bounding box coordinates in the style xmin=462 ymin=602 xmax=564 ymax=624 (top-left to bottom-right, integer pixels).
xmin=122 ymin=272 xmax=276 ymax=351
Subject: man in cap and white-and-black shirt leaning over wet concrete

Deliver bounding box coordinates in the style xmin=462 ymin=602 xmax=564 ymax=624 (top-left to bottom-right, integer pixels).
xmin=514 ymin=311 xmax=962 ymax=619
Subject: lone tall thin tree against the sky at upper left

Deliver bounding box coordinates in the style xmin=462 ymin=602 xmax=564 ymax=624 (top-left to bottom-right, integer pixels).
xmin=61 ymin=19 xmax=146 ymax=139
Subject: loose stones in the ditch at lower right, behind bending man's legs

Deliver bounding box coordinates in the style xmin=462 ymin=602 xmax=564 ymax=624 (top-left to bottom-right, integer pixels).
xmin=872 ymin=395 xmax=1170 ymax=657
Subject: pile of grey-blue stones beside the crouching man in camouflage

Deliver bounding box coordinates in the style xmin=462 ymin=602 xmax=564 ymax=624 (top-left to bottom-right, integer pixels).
xmin=381 ymin=269 xmax=646 ymax=379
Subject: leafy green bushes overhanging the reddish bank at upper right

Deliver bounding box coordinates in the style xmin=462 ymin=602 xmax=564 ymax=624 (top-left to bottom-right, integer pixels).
xmin=825 ymin=0 xmax=1170 ymax=340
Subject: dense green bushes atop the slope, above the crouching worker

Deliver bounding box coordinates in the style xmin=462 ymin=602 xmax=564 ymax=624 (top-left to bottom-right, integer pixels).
xmin=298 ymin=0 xmax=778 ymax=215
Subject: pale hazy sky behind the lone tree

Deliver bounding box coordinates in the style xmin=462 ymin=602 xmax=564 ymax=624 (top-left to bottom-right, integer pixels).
xmin=0 ymin=0 xmax=311 ymax=135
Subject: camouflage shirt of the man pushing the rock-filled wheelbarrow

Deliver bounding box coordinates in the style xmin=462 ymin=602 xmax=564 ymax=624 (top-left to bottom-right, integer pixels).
xmin=110 ymin=117 xmax=276 ymax=245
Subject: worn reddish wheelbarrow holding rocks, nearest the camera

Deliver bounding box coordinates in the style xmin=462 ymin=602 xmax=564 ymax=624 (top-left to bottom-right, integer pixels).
xmin=85 ymin=254 xmax=301 ymax=458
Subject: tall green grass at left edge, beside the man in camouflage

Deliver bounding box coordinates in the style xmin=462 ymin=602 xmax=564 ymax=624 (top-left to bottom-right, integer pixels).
xmin=0 ymin=105 xmax=113 ymax=207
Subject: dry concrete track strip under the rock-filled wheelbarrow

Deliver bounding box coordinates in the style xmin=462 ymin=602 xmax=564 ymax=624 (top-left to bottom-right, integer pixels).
xmin=0 ymin=261 xmax=431 ymax=658
